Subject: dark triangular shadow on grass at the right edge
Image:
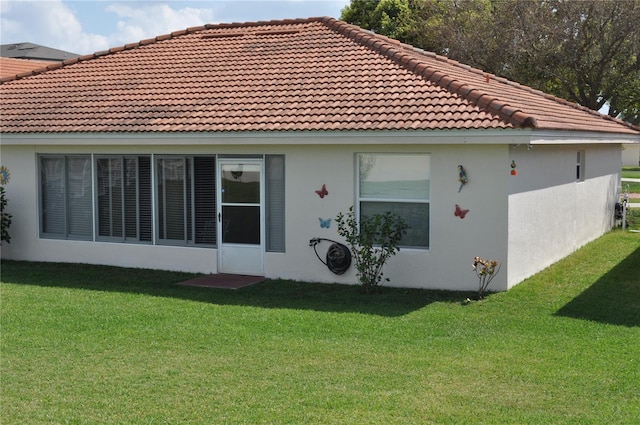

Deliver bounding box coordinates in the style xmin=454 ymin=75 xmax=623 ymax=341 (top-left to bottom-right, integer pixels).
xmin=556 ymin=248 xmax=640 ymax=326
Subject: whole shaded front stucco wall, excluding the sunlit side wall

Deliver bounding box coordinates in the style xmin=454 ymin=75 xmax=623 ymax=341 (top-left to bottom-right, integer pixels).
xmin=2 ymin=137 xmax=508 ymax=290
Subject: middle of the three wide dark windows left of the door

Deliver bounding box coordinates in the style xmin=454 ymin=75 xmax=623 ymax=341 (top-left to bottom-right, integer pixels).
xmin=96 ymin=156 xmax=152 ymax=242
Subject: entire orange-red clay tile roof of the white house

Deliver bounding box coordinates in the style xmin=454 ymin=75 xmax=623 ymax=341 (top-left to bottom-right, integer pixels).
xmin=0 ymin=18 xmax=640 ymax=135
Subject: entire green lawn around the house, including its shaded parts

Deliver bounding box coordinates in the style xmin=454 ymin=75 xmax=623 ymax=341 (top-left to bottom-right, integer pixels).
xmin=0 ymin=231 xmax=640 ymax=424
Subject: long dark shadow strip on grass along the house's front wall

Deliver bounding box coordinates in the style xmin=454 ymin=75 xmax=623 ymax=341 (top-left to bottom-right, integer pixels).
xmin=1 ymin=261 xmax=474 ymax=317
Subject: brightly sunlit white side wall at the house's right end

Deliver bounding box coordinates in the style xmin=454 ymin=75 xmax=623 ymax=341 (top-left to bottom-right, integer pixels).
xmin=508 ymin=145 xmax=620 ymax=287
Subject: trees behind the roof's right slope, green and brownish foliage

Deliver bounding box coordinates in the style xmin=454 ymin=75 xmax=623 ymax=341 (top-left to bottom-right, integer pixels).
xmin=342 ymin=0 xmax=640 ymax=125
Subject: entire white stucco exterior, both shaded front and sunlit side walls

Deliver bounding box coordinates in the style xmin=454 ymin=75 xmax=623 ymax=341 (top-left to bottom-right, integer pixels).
xmin=1 ymin=132 xmax=621 ymax=290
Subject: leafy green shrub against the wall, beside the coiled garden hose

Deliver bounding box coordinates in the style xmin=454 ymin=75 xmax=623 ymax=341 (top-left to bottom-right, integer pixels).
xmin=336 ymin=206 xmax=409 ymax=293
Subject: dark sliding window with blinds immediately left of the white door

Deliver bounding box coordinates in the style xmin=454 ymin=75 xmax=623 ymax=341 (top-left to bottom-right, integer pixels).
xmin=156 ymin=156 xmax=216 ymax=245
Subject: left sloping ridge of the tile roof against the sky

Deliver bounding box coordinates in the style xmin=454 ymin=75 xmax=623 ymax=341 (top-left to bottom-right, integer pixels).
xmin=0 ymin=18 xmax=324 ymax=84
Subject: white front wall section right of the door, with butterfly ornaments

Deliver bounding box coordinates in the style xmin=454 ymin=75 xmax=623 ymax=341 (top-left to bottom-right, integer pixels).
xmin=267 ymin=145 xmax=507 ymax=290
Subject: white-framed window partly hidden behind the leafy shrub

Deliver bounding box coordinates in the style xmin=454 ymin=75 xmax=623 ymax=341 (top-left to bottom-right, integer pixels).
xmin=357 ymin=154 xmax=431 ymax=248
